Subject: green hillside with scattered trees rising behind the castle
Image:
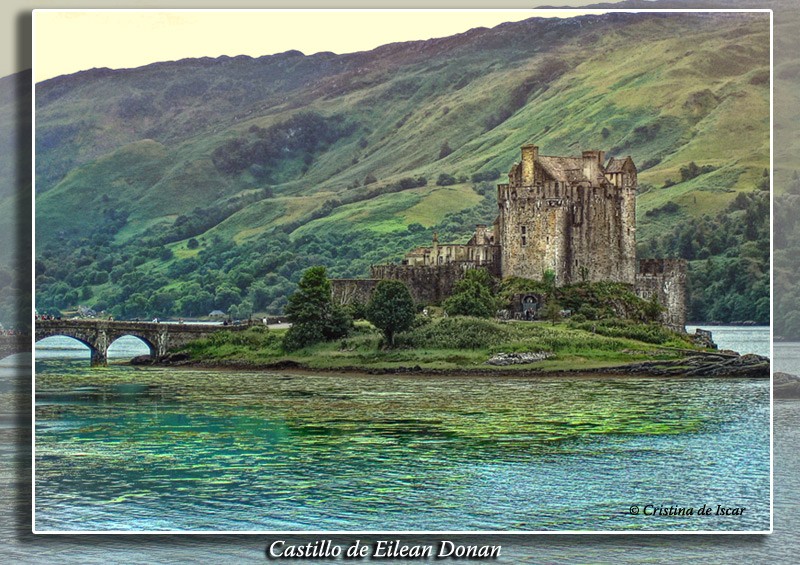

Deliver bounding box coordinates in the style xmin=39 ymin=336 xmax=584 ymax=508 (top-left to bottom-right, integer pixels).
xmin=36 ymin=14 xmax=770 ymax=319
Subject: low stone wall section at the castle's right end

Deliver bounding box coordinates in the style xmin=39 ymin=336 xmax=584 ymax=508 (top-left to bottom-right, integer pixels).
xmin=634 ymin=259 xmax=687 ymax=332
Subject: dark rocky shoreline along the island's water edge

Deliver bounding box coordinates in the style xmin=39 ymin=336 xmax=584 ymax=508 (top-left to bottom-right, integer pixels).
xmin=136 ymin=351 xmax=768 ymax=378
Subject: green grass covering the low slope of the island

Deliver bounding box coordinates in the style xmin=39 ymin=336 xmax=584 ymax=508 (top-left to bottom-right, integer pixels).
xmin=178 ymin=317 xmax=692 ymax=371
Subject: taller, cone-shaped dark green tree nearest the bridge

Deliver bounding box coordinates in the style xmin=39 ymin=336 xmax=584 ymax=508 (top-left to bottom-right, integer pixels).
xmin=283 ymin=267 xmax=353 ymax=351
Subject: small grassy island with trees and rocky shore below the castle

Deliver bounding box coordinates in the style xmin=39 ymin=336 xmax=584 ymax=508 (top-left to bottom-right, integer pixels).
xmin=161 ymin=267 xmax=770 ymax=378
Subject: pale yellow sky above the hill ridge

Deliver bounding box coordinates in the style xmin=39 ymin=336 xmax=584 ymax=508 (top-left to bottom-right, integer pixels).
xmin=33 ymin=7 xmax=604 ymax=82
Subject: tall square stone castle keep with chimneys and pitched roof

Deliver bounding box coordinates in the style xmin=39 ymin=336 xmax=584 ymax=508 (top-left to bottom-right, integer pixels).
xmin=496 ymin=145 xmax=637 ymax=285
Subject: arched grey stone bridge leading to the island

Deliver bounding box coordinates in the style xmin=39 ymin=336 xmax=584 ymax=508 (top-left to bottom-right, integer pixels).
xmin=36 ymin=320 xmax=250 ymax=366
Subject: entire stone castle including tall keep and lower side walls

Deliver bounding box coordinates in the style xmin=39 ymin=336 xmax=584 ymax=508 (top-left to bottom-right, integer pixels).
xmin=333 ymin=145 xmax=686 ymax=331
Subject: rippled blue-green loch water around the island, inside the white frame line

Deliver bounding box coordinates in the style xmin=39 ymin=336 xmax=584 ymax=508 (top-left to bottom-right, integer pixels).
xmin=34 ymin=328 xmax=770 ymax=532
